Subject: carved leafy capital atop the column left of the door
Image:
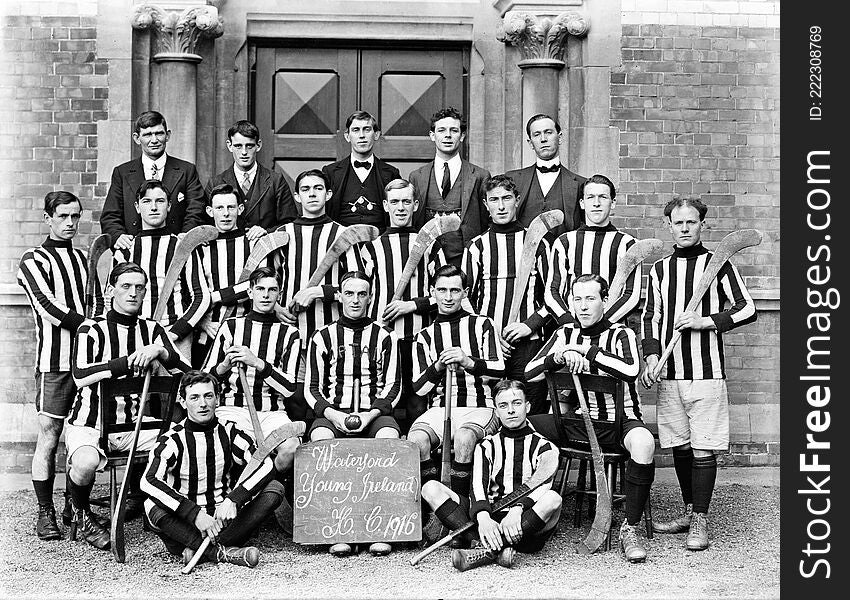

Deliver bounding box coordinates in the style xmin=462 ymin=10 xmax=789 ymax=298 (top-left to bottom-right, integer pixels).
xmin=130 ymin=2 xmax=224 ymax=62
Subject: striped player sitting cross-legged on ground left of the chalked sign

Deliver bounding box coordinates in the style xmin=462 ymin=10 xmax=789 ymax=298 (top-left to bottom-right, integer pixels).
xmin=142 ymin=371 xmax=283 ymax=567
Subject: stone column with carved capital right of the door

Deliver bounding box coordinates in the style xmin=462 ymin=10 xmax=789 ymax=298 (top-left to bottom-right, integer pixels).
xmin=498 ymin=11 xmax=589 ymax=165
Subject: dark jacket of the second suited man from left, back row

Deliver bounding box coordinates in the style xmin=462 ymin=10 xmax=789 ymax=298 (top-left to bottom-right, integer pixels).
xmin=207 ymin=164 xmax=298 ymax=231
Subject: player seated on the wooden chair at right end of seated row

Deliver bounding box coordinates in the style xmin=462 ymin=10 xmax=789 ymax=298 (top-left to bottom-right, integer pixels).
xmin=525 ymin=274 xmax=655 ymax=562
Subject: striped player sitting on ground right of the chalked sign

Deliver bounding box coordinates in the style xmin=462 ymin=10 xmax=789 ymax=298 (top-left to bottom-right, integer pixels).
xmin=422 ymin=379 xmax=561 ymax=571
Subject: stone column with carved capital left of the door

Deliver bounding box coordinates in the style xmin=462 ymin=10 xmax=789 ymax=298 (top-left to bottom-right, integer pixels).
xmin=131 ymin=3 xmax=224 ymax=163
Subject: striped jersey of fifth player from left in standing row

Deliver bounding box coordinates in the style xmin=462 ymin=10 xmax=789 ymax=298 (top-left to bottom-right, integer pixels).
xmin=360 ymin=227 xmax=433 ymax=340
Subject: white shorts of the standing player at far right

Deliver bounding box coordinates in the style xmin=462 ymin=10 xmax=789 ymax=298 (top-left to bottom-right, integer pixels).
xmin=656 ymin=379 xmax=729 ymax=452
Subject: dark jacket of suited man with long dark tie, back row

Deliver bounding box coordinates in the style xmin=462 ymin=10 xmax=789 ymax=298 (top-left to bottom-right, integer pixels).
xmin=409 ymin=160 xmax=490 ymax=254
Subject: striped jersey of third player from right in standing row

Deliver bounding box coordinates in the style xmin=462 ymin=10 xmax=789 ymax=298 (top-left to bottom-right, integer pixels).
xmin=462 ymin=221 xmax=548 ymax=338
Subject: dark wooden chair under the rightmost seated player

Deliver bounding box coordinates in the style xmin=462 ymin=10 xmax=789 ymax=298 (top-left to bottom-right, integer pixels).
xmin=546 ymin=371 xmax=652 ymax=550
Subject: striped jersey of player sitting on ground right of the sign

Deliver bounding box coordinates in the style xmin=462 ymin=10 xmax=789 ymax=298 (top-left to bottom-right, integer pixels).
xmin=469 ymin=422 xmax=558 ymax=519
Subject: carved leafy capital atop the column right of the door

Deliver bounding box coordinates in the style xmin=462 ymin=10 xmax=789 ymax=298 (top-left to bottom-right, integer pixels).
xmin=497 ymin=11 xmax=590 ymax=68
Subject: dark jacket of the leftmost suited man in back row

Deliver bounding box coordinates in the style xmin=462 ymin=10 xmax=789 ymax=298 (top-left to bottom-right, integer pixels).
xmin=100 ymin=156 xmax=207 ymax=244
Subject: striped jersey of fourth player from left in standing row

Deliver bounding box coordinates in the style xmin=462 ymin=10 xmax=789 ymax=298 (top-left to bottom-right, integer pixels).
xmin=281 ymin=215 xmax=360 ymax=340
